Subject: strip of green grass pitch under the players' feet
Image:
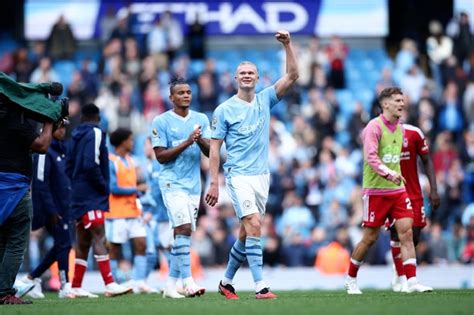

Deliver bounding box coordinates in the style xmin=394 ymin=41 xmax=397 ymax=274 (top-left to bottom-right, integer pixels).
xmin=0 ymin=290 xmax=474 ymax=315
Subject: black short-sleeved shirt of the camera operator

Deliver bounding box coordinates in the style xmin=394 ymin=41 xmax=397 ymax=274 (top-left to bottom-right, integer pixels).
xmin=0 ymin=110 xmax=38 ymax=178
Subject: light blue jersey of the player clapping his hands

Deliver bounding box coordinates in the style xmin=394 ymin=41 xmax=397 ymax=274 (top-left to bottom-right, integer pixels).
xmin=151 ymin=110 xmax=211 ymax=195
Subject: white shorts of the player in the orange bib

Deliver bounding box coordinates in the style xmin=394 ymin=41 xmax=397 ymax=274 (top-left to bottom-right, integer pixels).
xmin=105 ymin=217 xmax=146 ymax=244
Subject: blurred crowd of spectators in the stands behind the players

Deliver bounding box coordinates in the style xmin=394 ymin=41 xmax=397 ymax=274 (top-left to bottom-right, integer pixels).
xmin=0 ymin=8 xmax=474 ymax=282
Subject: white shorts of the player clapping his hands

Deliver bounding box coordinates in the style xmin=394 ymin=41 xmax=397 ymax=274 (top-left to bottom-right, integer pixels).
xmin=162 ymin=191 xmax=200 ymax=231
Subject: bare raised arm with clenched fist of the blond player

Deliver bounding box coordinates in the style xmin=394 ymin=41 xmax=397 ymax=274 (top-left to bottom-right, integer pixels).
xmin=275 ymin=31 xmax=298 ymax=99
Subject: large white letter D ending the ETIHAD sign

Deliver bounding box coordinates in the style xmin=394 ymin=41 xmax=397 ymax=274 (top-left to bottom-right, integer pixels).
xmin=262 ymin=2 xmax=308 ymax=32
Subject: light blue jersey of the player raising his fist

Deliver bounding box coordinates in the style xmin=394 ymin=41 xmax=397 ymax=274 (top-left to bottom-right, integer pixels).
xmin=212 ymin=85 xmax=279 ymax=176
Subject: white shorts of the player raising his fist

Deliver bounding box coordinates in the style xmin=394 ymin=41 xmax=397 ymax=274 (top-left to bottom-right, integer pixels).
xmin=226 ymin=174 xmax=270 ymax=219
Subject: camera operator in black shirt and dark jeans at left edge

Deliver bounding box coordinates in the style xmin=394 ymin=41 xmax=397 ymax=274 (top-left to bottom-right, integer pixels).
xmin=0 ymin=105 xmax=53 ymax=304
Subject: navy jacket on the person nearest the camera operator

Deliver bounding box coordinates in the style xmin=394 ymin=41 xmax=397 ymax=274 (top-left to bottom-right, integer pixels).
xmin=31 ymin=140 xmax=71 ymax=230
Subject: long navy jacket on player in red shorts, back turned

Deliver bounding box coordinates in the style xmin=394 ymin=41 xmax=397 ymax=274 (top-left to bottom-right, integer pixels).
xmin=66 ymin=123 xmax=109 ymax=219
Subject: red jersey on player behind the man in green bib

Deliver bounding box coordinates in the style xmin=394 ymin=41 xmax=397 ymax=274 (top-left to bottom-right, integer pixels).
xmin=400 ymin=124 xmax=430 ymax=199
